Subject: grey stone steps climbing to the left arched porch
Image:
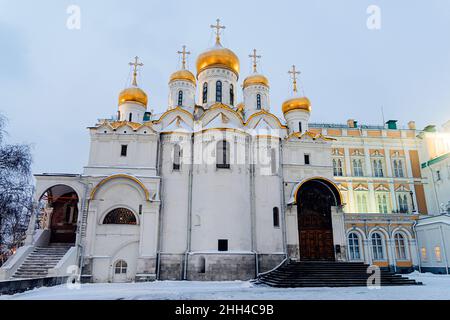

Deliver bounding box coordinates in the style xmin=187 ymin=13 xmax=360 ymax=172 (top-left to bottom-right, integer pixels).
xmin=12 ymin=244 xmax=71 ymax=279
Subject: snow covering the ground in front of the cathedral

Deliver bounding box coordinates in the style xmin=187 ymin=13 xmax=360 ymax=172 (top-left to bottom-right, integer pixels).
xmin=0 ymin=272 xmax=450 ymax=300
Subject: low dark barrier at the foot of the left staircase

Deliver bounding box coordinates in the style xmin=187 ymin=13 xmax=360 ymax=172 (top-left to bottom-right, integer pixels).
xmin=0 ymin=276 xmax=69 ymax=295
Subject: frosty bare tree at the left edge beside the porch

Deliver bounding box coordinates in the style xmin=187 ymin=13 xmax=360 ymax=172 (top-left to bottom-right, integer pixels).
xmin=0 ymin=115 xmax=33 ymax=264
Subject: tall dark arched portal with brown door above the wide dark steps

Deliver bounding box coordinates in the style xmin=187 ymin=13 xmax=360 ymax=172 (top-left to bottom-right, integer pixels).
xmin=296 ymin=179 xmax=341 ymax=261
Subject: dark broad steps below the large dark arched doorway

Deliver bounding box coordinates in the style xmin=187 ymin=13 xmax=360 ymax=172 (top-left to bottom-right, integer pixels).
xmin=255 ymin=262 xmax=422 ymax=288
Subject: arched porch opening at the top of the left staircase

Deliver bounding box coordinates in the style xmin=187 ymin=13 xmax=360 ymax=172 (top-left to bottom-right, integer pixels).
xmin=40 ymin=185 xmax=78 ymax=243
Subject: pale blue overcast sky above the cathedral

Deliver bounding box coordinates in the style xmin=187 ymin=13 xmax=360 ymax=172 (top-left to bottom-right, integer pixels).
xmin=0 ymin=0 xmax=450 ymax=173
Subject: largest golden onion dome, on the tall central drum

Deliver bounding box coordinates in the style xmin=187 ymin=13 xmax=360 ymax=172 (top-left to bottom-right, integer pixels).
xmin=197 ymin=43 xmax=239 ymax=77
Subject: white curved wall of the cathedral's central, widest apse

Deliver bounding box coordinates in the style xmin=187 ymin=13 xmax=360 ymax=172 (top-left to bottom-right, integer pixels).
xmin=192 ymin=131 xmax=252 ymax=252
